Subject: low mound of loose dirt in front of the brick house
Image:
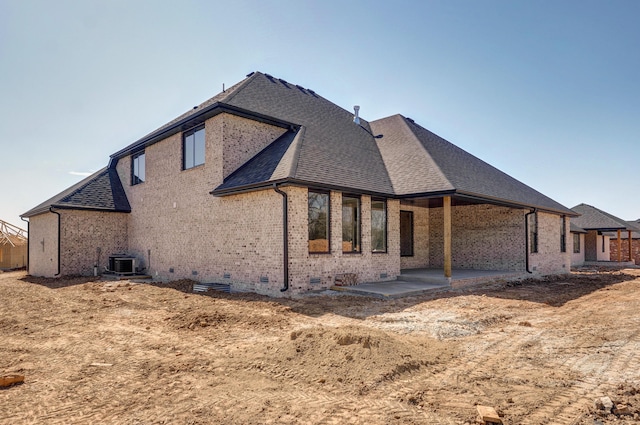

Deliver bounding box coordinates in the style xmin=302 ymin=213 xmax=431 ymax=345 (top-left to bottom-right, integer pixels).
xmin=253 ymin=326 xmax=455 ymax=394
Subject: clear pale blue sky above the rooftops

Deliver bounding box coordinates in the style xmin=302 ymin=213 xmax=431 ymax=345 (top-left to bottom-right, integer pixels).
xmin=0 ymin=0 xmax=640 ymax=228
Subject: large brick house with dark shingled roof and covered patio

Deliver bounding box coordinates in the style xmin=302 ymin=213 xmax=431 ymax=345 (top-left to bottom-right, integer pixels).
xmin=23 ymin=72 xmax=576 ymax=295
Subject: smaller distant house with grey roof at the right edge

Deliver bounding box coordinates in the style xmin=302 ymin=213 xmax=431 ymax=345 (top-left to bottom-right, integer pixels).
xmin=571 ymin=204 xmax=640 ymax=265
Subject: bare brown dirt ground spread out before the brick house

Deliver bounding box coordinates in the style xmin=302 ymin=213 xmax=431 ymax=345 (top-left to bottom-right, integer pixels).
xmin=0 ymin=269 xmax=640 ymax=425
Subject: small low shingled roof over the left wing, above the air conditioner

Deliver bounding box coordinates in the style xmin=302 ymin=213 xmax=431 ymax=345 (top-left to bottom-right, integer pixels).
xmin=22 ymin=167 xmax=131 ymax=217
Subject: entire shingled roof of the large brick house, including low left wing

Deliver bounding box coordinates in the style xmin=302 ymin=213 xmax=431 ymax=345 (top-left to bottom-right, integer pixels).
xmin=24 ymin=72 xmax=575 ymax=217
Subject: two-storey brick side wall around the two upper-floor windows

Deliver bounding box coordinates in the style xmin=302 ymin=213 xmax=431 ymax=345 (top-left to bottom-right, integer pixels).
xmin=117 ymin=114 xmax=290 ymax=295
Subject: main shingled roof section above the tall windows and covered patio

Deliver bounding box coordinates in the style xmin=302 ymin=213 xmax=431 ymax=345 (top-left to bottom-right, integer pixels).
xmin=212 ymin=73 xmax=575 ymax=216
